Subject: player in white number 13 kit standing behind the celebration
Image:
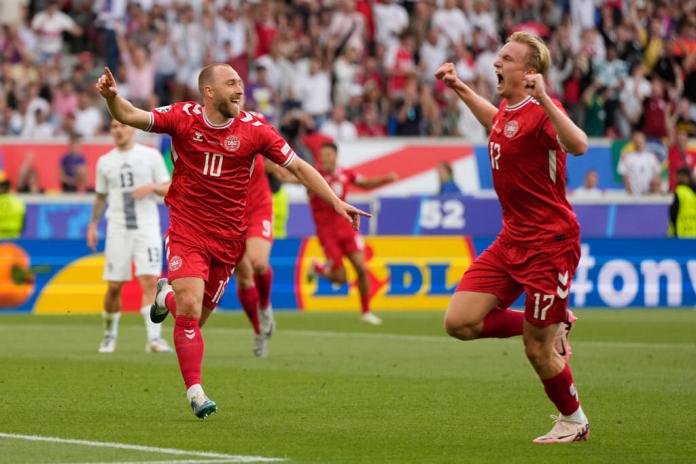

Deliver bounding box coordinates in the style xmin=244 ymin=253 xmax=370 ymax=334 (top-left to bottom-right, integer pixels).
xmin=87 ymin=120 xmax=172 ymax=353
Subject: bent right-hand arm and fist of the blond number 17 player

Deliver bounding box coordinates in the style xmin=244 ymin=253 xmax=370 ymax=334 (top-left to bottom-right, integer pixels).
xmin=525 ymin=74 xmax=588 ymax=156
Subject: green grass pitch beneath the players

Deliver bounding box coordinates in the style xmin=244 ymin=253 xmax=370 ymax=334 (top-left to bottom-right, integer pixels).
xmin=0 ymin=310 xmax=696 ymax=464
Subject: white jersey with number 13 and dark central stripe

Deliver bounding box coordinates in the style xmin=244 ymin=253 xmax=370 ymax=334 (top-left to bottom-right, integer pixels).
xmin=95 ymin=143 xmax=171 ymax=230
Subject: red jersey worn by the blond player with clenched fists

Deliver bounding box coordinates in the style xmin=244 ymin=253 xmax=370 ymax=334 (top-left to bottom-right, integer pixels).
xmin=488 ymin=97 xmax=580 ymax=247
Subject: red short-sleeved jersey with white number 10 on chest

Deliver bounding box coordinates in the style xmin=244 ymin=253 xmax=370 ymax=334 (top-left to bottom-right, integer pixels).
xmin=147 ymin=102 xmax=295 ymax=240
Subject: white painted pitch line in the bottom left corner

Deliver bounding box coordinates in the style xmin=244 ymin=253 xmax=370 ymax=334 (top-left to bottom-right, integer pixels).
xmin=0 ymin=432 xmax=286 ymax=462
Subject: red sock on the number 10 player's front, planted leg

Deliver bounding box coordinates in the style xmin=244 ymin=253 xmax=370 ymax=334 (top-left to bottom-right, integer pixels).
xmin=170 ymin=316 xmax=203 ymax=388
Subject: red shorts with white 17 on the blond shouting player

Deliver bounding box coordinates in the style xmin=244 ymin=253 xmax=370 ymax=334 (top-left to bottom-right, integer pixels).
xmin=457 ymin=240 xmax=580 ymax=327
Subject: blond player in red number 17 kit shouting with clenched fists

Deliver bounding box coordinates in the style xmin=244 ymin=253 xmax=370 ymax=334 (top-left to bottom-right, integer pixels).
xmin=436 ymin=32 xmax=589 ymax=443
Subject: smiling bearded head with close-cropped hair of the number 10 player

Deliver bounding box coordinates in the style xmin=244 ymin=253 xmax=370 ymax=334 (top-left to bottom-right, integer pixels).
xmin=198 ymin=63 xmax=244 ymax=118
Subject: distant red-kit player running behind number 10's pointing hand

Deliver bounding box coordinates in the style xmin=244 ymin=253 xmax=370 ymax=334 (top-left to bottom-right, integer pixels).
xmin=308 ymin=143 xmax=397 ymax=325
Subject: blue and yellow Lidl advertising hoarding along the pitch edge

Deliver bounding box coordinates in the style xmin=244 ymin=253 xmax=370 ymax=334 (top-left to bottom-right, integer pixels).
xmin=0 ymin=236 xmax=696 ymax=314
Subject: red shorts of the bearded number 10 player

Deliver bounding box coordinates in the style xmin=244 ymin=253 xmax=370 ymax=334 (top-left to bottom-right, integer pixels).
xmin=165 ymin=229 xmax=246 ymax=309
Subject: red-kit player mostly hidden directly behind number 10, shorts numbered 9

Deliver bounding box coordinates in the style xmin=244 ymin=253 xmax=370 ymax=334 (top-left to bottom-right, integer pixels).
xmin=234 ymin=156 xmax=275 ymax=358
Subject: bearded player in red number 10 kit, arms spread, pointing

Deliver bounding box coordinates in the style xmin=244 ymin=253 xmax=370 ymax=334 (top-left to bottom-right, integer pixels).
xmin=96 ymin=64 xmax=369 ymax=419
